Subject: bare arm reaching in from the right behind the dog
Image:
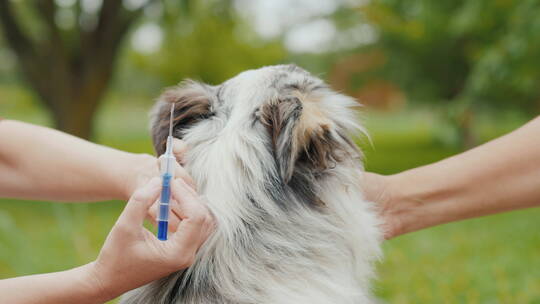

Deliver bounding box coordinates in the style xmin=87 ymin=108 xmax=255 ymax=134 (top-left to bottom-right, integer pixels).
xmin=365 ymin=118 xmax=540 ymax=238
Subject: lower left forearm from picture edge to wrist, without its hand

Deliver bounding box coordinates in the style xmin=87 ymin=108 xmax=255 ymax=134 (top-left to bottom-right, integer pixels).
xmin=0 ymin=263 xmax=112 ymax=304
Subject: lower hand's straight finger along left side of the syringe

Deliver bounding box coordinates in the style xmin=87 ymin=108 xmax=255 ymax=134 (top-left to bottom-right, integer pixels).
xmin=118 ymin=177 xmax=161 ymax=225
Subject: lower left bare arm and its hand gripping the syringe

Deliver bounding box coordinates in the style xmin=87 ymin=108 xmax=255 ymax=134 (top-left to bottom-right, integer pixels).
xmin=0 ymin=179 xmax=214 ymax=304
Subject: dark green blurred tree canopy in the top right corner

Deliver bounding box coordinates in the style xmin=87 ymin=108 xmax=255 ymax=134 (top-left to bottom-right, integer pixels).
xmin=360 ymin=0 xmax=540 ymax=112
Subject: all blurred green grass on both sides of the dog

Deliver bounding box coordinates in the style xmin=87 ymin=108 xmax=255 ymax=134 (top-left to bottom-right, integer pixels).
xmin=0 ymin=88 xmax=540 ymax=303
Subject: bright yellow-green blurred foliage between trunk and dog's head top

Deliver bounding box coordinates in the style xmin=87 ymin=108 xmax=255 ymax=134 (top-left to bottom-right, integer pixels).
xmin=131 ymin=0 xmax=286 ymax=85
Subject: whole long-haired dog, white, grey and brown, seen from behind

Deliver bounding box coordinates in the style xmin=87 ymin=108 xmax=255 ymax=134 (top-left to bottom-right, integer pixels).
xmin=122 ymin=65 xmax=381 ymax=304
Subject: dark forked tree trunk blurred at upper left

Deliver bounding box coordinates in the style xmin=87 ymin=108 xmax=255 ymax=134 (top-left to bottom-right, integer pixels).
xmin=0 ymin=0 xmax=152 ymax=138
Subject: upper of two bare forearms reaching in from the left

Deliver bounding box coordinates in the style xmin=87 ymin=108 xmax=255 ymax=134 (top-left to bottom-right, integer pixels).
xmin=0 ymin=120 xmax=152 ymax=201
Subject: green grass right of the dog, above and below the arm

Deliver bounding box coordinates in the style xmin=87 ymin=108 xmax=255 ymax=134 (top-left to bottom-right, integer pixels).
xmin=366 ymin=113 xmax=540 ymax=303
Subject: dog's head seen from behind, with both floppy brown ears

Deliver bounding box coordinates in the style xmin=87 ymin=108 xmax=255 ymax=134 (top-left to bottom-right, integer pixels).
xmin=152 ymin=65 xmax=364 ymax=192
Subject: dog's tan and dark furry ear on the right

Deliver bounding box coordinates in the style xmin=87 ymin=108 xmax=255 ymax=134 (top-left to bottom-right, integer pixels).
xmin=259 ymin=96 xmax=356 ymax=183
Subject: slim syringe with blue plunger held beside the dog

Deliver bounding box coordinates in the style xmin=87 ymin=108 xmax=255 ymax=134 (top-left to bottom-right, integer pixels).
xmin=157 ymin=103 xmax=176 ymax=241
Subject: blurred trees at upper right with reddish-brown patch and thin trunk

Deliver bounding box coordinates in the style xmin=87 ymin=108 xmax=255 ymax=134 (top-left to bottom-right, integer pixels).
xmin=304 ymin=0 xmax=540 ymax=148
